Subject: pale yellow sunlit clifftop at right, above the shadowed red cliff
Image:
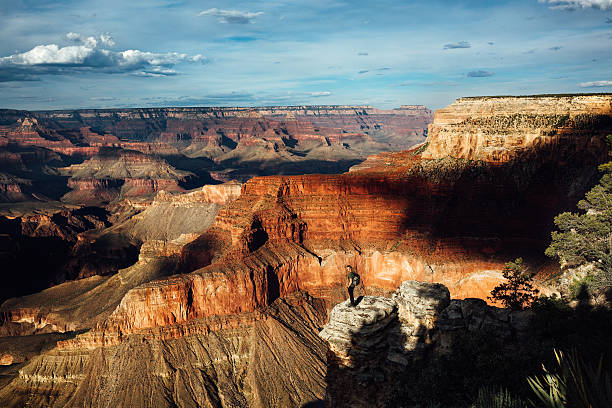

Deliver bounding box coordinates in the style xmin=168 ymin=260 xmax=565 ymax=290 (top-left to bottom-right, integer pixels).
xmin=423 ymin=94 xmax=612 ymax=163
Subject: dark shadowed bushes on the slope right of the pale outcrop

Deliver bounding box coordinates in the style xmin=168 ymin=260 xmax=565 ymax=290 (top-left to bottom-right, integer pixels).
xmin=386 ymin=296 xmax=612 ymax=408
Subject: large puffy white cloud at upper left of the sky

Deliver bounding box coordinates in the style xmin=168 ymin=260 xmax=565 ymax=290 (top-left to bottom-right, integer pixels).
xmin=0 ymin=32 xmax=207 ymax=81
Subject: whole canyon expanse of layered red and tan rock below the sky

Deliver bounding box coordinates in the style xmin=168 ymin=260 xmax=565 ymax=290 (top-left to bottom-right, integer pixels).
xmin=0 ymin=94 xmax=612 ymax=407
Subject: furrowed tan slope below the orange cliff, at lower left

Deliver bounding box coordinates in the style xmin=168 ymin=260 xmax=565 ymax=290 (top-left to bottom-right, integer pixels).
xmin=0 ymin=294 xmax=325 ymax=408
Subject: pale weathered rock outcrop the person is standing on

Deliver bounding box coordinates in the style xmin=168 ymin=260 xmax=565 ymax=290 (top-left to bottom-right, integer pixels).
xmin=319 ymin=281 xmax=530 ymax=408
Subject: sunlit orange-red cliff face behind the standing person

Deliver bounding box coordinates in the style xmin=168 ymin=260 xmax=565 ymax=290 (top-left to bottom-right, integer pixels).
xmin=68 ymin=168 xmax=548 ymax=347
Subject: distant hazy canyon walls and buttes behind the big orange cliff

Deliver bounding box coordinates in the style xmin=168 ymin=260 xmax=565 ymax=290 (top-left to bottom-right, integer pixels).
xmin=0 ymin=106 xmax=432 ymax=207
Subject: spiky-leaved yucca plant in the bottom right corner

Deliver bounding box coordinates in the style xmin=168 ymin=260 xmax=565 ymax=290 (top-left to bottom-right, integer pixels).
xmin=527 ymin=350 xmax=612 ymax=408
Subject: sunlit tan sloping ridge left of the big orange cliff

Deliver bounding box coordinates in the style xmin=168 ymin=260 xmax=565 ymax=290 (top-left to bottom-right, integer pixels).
xmin=0 ymin=183 xmax=240 ymax=336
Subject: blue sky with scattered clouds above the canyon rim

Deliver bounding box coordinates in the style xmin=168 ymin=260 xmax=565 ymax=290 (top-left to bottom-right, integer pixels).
xmin=0 ymin=0 xmax=612 ymax=110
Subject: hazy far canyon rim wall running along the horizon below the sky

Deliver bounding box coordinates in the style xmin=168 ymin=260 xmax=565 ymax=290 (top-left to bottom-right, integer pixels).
xmin=0 ymin=106 xmax=432 ymax=157
